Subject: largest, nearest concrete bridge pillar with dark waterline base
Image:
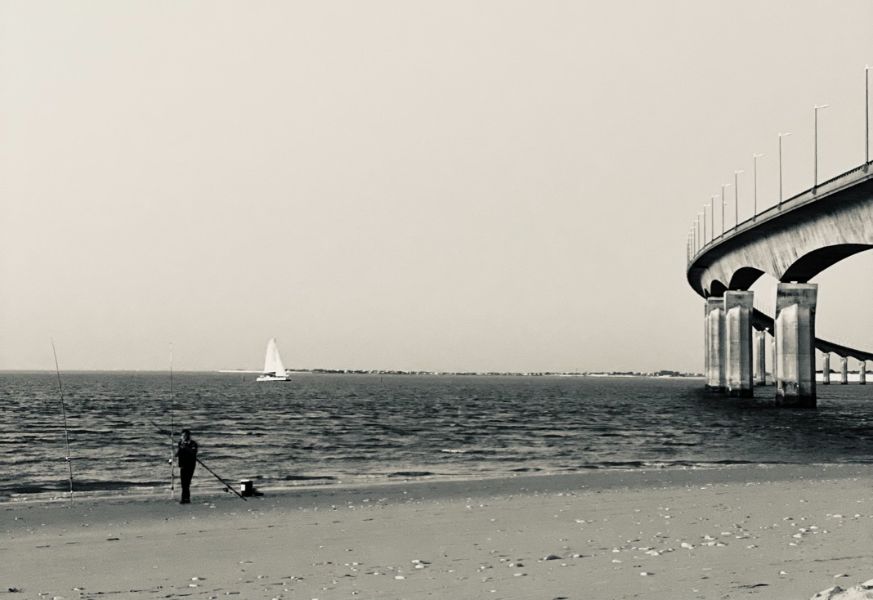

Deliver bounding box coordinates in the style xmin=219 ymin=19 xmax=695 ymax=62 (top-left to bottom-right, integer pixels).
xmin=774 ymin=283 xmax=818 ymax=408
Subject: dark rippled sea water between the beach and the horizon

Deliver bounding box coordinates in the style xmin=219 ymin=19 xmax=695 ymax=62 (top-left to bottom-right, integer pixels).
xmin=0 ymin=373 xmax=873 ymax=500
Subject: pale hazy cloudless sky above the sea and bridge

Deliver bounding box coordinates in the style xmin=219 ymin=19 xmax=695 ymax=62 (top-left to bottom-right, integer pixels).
xmin=0 ymin=0 xmax=873 ymax=371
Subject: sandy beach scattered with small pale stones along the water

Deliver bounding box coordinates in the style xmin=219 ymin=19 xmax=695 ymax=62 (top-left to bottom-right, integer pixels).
xmin=0 ymin=466 xmax=873 ymax=600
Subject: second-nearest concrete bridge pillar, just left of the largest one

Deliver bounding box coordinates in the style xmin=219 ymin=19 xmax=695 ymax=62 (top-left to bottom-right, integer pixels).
xmin=724 ymin=291 xmax=755 ymax=398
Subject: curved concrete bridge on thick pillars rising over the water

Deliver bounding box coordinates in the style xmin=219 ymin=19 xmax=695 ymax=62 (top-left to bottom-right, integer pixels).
xmin=687 ymin=161 xmax=873 ymax=407
